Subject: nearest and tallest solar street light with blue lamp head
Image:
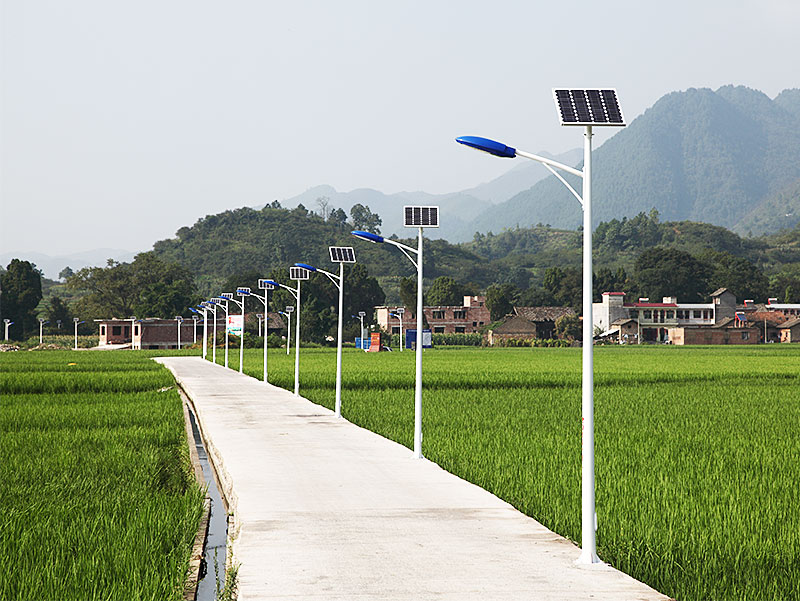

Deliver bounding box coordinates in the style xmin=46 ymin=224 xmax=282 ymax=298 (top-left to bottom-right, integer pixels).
xmin=456 ymin=89 xmax=625 ymax=563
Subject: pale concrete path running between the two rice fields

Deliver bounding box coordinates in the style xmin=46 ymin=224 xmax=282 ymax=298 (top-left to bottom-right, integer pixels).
xmin=158 ymin=357 xmax=667 ymax=601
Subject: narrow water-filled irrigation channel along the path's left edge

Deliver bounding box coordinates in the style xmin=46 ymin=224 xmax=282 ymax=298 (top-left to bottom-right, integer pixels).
xmin=187 ymin=404 xmax=228 ymax=601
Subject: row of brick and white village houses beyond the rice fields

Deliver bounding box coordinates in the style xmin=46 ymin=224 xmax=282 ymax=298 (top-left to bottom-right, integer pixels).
xmin=98 ymin=288 xmax=800 ymax=349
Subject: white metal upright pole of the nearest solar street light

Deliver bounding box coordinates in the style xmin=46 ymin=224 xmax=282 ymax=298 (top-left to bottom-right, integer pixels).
xmin=578 ymin=125 xmax=600 ymax=563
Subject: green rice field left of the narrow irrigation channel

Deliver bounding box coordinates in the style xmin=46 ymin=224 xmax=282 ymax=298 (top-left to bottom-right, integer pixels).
xmin=0 ymin=351 xmax=203 ymax=601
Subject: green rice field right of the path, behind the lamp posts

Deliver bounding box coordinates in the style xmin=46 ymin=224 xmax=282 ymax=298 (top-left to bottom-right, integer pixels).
xmin=217 ymin=345 xmax=800 ymax=601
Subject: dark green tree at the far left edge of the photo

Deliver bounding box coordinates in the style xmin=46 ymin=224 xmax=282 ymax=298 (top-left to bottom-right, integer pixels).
xmin=0 ymin=259 xmax=42 ymax=340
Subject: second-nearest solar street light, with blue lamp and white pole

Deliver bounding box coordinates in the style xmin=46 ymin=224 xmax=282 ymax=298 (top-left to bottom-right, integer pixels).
xmin=351 ymin=206 xmax=439 ymax=459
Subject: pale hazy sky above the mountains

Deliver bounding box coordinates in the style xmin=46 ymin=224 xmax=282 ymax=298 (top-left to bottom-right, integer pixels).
xmin=0 ymin=0 xmax=800 ymax=254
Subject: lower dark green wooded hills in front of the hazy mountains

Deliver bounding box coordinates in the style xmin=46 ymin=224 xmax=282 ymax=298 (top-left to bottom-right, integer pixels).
xmin=154 ymin=203 xmax=800 ymax=302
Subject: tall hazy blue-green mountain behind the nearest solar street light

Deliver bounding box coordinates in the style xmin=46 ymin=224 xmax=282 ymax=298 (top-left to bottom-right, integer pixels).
xmin=469 ymin=86 xmax=800 ymax=235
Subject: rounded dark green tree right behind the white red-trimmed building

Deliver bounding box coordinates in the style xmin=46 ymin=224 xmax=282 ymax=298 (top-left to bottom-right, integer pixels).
xmin=635 ymin=246 xmax=709 ymax=303
